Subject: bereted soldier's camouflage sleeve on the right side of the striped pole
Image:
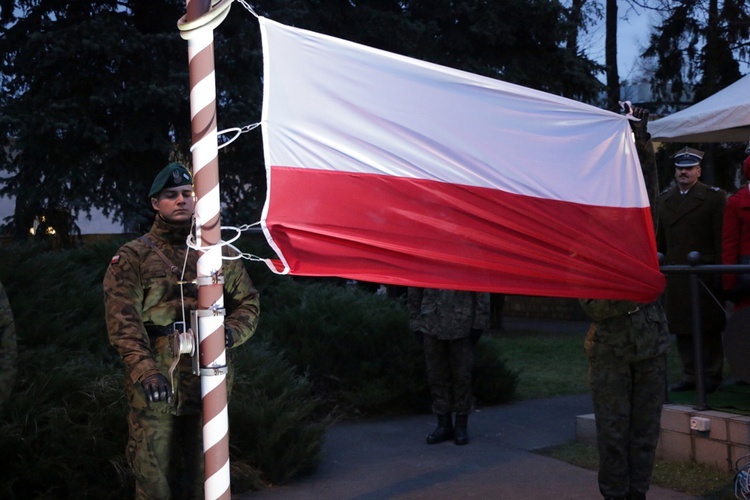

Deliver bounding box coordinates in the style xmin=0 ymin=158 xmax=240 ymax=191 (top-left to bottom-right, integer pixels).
xmin=222 ymin=260 xmax=260 ymax=347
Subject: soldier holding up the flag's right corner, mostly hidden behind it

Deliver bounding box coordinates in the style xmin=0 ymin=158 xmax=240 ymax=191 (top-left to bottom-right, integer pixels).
xmin=580 ymin=108 xmax=670 ymax=500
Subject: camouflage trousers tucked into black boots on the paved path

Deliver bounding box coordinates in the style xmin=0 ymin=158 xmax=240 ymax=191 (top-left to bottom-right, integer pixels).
xmin=423 ymin=335 xmax=474 ymax=415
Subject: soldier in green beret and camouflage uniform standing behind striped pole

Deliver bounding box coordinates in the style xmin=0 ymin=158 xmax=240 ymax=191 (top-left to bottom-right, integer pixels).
xmin=104 ymin=163 xmax=260 ymax=499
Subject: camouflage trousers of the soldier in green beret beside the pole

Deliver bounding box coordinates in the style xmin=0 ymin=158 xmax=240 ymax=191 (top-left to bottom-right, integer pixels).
xmin=125 ymin=403 xmax=204 ymax=500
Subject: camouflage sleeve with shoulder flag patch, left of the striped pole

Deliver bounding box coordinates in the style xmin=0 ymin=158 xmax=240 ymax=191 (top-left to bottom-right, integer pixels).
xmin=103 ymin=247 xmax=159 ymax=383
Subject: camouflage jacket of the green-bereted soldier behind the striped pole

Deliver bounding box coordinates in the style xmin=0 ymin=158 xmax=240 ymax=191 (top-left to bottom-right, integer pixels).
xmin=104 ymin=216 xmax=260 ymax=413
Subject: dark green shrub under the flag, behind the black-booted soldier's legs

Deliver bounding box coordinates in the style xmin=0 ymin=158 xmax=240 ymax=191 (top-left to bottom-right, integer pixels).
xmin=262 ymin=280 xmax=518 ymax=414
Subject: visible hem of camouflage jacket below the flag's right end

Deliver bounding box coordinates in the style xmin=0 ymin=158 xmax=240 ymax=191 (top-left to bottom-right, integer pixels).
xmin=580 ymin=299 xmax=670 ymax=364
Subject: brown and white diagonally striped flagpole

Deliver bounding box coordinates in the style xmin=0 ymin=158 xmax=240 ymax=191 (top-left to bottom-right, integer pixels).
xmin=177 ymin=0 xmax=231 ymax=500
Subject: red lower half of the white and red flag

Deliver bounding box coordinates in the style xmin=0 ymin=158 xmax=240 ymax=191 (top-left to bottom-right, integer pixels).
xmin=264 ymin=167 xmax=664 ymax=302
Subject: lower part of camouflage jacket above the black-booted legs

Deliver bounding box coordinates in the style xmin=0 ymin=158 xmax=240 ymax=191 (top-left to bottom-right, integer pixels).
xmin=407 ymin=288 xmax=490 ymax=340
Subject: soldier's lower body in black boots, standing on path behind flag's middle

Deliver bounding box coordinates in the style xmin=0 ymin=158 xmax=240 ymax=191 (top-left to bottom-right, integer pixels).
xmin=407 ymin=288 xmax=490 ymax=445
